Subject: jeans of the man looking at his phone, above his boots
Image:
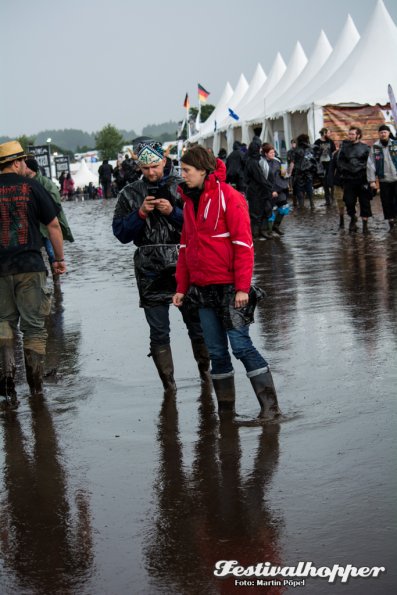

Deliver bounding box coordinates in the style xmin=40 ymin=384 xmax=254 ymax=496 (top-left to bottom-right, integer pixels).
xmin=144 ymin=304 xmax=203 ymax=347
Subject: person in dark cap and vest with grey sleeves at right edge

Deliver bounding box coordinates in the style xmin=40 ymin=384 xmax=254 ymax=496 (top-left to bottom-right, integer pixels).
xmin=367 ymin=124 xmax=397 ymax=231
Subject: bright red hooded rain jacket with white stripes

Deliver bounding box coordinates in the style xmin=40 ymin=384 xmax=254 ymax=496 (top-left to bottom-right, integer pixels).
xmin=176 ymin=163 xmax=254 ymax=293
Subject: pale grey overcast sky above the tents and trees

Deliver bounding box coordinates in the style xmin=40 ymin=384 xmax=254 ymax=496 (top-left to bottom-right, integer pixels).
xmin=0 ymin=0 xmax=397 ymax=136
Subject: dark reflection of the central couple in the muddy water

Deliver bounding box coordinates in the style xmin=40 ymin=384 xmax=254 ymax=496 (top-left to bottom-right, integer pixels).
xmin=146 ymin=392 xmax=284 ymax=595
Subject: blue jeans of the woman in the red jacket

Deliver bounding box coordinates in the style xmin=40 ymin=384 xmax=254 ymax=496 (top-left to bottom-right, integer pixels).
xmin=199 ymin=308 xmax=268 ymax=377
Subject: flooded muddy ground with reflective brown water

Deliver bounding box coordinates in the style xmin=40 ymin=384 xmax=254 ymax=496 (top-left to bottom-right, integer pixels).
xmin=0 ymin=198 xmax=397 ymax=595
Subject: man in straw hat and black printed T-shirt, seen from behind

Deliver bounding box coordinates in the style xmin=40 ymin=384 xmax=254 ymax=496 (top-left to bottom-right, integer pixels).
xmin=0 ymin=140 xmax=66 ymax=408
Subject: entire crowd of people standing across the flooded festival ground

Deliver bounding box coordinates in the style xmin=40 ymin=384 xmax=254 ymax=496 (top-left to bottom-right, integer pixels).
xmin=0 ymin=125 xmax=397 ymax=422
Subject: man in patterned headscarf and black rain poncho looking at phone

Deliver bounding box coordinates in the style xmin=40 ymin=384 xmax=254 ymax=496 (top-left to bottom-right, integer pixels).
xmin=113 ymin=141 xmax=209 ymax=394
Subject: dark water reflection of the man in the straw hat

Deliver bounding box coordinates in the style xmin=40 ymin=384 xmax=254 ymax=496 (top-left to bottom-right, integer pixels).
xmin=0 ymin=400 xmax=93 ymax=594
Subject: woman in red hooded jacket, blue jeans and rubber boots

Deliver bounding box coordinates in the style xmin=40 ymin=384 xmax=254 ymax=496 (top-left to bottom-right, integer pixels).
xmin=173 ymin=146 xmax=281 ymax=419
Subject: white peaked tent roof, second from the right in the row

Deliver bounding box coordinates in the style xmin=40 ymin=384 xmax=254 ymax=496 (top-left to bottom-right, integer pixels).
xmin=288 ymin=15 xmax=360 ymax=111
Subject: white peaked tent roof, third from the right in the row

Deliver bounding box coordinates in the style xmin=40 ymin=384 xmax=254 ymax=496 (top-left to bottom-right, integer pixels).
xmin=268 ymin=31 xmax=332 ymax=117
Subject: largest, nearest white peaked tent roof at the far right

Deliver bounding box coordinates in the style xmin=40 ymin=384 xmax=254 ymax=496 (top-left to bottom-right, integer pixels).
xmin=304 ymin=0 xmax=397 ymax=106
